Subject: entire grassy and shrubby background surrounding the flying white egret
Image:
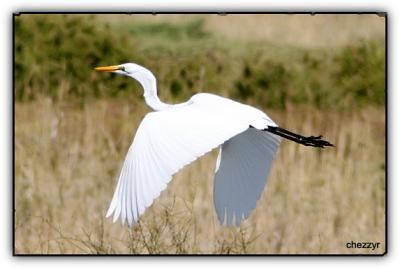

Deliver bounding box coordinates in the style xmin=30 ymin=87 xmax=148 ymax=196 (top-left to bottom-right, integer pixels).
xmin=15 ymin=15 xmax=386 ymax=253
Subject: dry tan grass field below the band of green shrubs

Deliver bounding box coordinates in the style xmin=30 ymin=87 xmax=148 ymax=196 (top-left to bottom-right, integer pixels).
xmin=15 ymin=98 xmax=385 ymax=254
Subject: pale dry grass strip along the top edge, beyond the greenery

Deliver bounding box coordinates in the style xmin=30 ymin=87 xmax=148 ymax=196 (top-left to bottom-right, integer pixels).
xmin=101 ymin=14 xmax=385 ymax=48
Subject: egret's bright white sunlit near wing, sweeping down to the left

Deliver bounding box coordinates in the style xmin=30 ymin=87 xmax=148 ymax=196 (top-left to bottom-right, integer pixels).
xmin=107 ymin=99 xmax=249 ymax=226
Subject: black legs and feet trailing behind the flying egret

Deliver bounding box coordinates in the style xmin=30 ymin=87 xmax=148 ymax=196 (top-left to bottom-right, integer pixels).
xmin=264 ymin=126 xmax=334 ymax=148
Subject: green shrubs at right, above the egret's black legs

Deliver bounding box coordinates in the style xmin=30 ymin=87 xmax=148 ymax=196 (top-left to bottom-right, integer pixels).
xmin=232 ymin=40 xmax=385 ymax=109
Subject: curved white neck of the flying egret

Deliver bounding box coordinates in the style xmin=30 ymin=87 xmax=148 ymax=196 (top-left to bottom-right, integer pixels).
xmin=133 ymin=72 xmax=171 ymax=111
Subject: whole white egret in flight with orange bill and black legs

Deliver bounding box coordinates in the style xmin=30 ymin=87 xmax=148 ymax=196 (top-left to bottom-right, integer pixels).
xmin=95 ymin=63 xmax=333 ymax=227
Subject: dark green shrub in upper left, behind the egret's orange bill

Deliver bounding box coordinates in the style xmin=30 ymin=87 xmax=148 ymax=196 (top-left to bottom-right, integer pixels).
xmin=15 ymin=15 xmax=140 ymax=100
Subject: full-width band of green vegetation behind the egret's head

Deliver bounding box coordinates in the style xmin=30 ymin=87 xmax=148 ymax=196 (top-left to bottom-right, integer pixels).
xmin=15 ymin=15 xmax=385 ymax=109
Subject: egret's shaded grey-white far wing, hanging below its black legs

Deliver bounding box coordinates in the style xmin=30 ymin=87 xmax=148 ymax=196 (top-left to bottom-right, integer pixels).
xmin=214 ymin=128 xmax=280 ymax=226
